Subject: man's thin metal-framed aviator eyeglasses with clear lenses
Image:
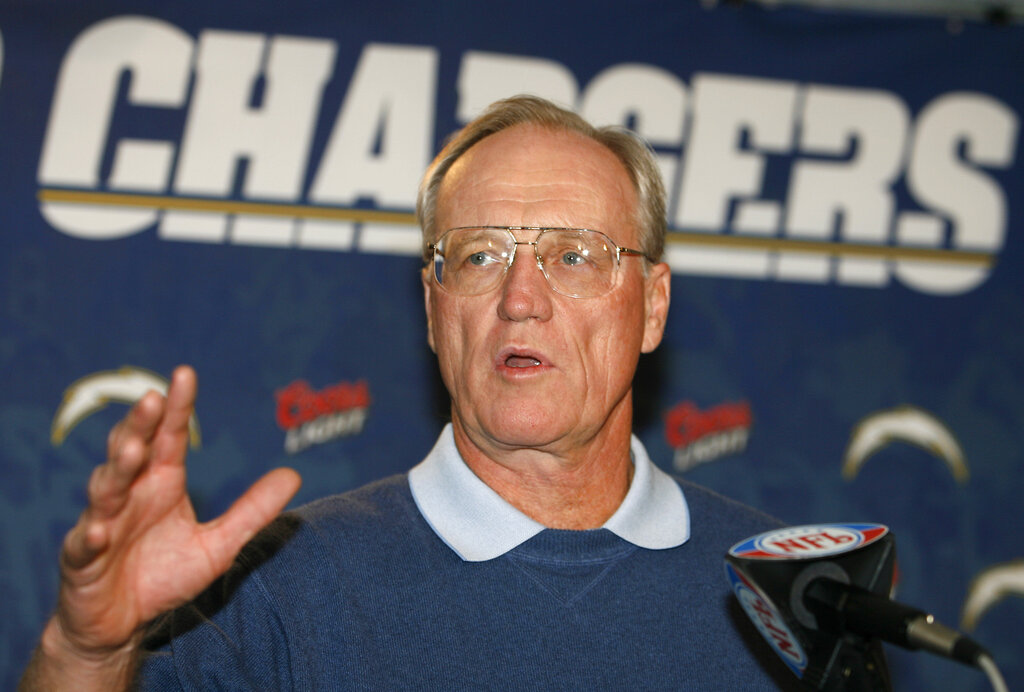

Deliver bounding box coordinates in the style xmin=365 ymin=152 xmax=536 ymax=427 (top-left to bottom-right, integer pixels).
xmin=427 ymin=226 xmax=653 ymax=298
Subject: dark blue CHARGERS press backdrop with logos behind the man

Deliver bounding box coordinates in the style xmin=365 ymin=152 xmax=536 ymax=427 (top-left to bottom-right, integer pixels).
xmin=0 ymin=0 xmax=1024 ymax=690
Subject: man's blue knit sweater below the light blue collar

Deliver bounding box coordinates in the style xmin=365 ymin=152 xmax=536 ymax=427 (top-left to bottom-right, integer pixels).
xmin=141 ymin=476 xmax=795 ymax=690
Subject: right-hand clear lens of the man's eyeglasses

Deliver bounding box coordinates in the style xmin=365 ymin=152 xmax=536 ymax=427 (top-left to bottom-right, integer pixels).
xmin=537 ymin=230 xmax=615 ymax=298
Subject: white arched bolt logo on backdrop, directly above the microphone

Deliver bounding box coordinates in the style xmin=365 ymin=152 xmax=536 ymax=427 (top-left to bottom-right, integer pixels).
xmin=843 ymin=406 xmax=970 ymax=483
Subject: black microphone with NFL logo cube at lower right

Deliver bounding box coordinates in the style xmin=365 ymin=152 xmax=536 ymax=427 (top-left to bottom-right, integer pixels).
xmin=725 ymin=523 xmax=988 ymax=691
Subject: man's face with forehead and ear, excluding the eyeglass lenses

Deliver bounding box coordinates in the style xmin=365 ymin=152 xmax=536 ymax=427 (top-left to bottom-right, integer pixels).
xmin=423 ymin=125 xmax=670 ymax=452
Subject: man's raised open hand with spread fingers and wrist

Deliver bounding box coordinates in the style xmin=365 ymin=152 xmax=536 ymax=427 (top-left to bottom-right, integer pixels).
xmin=22 ymin=366 xmax=300 ymax=690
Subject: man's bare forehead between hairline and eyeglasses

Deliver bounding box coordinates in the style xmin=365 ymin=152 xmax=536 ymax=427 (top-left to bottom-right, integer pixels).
xmin=437 ymin=125 xmax=636 ymax=243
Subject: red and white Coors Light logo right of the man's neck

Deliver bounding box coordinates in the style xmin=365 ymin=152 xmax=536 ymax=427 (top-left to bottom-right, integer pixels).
xmin=665 ymin=401 xmax=753 ymax=471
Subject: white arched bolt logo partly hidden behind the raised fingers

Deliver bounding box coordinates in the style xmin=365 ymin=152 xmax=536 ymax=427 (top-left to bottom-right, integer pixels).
xmin=50 ymin=365 xmax=200 ymax=447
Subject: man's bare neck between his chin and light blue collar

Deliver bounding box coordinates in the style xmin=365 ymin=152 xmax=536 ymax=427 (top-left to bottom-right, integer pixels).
xmin=453 ymin=406 xmax=633 ymax=529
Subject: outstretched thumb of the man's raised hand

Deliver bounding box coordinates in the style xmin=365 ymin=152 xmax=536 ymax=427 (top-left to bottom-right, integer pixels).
xmin=199 ymin=468 xmax=302 ymax=570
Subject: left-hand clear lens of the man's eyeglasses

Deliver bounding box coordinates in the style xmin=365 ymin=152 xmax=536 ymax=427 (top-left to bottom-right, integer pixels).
xmin=434 ymin=228 xmax=515 ymax=296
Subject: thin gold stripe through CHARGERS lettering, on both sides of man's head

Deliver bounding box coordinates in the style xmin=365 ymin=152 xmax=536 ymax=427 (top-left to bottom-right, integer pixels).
xmin=39 ymin=189 xmax=994 ymax=267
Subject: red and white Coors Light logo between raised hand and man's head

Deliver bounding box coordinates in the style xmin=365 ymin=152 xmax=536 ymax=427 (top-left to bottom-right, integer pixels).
xmin=274 ymin=380 xmax=370 ymax=455
